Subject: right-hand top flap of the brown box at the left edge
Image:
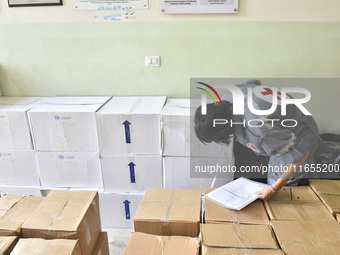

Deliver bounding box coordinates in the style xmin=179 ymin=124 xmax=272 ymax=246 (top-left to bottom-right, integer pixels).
xmin=0 ymin=195 xmax=44 ymax=233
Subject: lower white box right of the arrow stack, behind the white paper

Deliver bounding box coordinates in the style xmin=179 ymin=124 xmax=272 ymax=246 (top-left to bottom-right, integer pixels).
xmin=163 ymin=157 xmax=234 ymax=191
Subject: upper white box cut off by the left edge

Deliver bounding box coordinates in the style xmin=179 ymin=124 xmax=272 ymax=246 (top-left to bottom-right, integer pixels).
xmin=0 ymin=105 xmax=33 ymax=150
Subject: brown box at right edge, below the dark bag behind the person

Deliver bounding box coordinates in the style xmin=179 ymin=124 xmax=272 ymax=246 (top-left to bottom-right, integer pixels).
xmin=309 ymin=179 xmax=340 ymax=217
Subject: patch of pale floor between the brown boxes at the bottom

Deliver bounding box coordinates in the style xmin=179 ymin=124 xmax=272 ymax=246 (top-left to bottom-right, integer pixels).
xmin=103 ymin=228 xmax=133 ymax=255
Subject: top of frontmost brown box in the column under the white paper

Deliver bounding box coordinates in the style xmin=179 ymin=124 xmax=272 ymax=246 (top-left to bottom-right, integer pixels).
xmin=201 ymin=223 xmax=278 ymax=249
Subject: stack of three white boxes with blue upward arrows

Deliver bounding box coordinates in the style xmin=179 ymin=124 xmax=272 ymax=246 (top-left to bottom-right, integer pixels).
xmin=96 ymin=97 xmax=166 ymax=228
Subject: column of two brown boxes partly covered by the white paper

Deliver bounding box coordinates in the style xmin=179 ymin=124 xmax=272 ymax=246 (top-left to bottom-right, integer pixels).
xmin=201 ymin=188 xmax=283 ymax=255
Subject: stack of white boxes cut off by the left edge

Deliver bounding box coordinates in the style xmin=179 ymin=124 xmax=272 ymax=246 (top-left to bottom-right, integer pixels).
xmin=0 ymin=96 xmax=40 ymax=195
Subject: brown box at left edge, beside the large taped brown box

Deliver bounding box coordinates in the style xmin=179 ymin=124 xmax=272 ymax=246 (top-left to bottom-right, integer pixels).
xmin=0 ymin=195 xmax=44 ymax=236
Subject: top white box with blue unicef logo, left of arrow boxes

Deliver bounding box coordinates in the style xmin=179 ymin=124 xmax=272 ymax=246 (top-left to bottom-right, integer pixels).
xmin=28 ymin=97 xmax=109 ymax=151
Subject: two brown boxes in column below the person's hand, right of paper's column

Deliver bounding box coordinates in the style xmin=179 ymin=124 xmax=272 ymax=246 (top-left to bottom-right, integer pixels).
xmin=265 ymin=187 xmax=340 ymax=254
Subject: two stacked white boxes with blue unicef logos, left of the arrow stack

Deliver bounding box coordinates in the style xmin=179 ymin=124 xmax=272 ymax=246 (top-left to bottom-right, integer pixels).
xmin=28 ymin=97 xmax=110 ymax=190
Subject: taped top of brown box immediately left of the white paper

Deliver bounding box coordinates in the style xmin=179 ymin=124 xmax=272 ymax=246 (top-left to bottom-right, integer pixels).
xmin=134 ymin=189 xmax=201 ymax=222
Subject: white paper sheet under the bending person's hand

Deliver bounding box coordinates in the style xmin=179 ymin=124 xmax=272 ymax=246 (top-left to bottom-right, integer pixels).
xmin=205 ymin=177 xmax=267 ymax=210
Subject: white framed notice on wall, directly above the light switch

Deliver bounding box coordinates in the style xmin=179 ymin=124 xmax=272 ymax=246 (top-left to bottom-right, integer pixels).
xmin=160 ymin=0 xmax=238 ymax=14
